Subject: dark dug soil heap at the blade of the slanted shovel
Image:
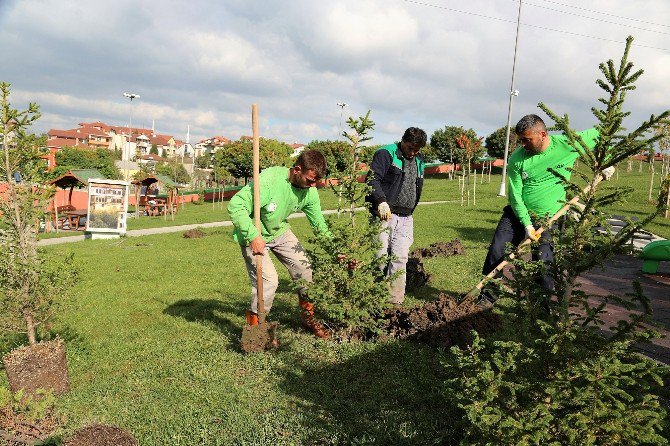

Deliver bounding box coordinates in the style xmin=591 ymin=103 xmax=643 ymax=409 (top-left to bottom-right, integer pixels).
xmin=384 ymin=293 xmax=499 ymax=348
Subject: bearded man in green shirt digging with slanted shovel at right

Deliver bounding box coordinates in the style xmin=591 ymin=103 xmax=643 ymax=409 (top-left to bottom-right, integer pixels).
xmin=480 ymin=115 xmax=614 ymax=306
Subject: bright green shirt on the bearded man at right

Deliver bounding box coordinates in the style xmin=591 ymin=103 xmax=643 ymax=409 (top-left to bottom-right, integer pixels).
xmin=509 ymin=129 xmax=598 ymax=226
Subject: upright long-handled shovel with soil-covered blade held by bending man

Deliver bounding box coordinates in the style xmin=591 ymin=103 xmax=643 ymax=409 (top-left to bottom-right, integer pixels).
xmin=242 ymin=104 xmax=278 ymax=353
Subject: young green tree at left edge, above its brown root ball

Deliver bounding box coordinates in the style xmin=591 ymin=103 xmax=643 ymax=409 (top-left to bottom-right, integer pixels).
xmin=0 ymin=82 xmax=76 ymax=345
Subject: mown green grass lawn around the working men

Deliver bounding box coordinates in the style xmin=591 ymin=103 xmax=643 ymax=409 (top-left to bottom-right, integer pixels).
xmin=5 ymin=167 xmax=670 ymax=445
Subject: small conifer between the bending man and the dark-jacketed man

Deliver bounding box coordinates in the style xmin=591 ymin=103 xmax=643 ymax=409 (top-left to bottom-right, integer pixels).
xmin=302 ymin=111 xmax=392 ymax=334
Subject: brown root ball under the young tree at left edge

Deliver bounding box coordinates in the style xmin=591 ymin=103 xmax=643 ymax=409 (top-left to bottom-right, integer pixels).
xmin=2 ymin=339 xmax=70 ymax=395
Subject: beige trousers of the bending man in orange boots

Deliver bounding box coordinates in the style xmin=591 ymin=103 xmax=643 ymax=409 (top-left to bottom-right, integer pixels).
xmin=240 ymin=229 xmax=312 ymax=313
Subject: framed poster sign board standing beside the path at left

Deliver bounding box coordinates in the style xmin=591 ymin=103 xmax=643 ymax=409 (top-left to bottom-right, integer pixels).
xmin=86 ymin=179 xmax=129 ymax=235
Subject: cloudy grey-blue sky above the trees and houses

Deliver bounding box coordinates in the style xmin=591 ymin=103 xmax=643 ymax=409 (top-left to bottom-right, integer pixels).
xmin=0 ymin=0 xmax=670 ymax=143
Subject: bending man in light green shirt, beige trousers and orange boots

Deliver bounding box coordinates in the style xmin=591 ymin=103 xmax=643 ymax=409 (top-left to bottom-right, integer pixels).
xmin=228 ymin=150 xmax=328 ymax=338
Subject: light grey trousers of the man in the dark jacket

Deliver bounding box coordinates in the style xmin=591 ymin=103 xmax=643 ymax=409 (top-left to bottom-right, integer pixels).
xmin=377 ymin=214 xmax=414 ymax=305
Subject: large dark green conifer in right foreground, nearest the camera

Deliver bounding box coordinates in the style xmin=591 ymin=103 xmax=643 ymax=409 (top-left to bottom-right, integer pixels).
xmin=447 ymin=37 xmax=670 ymax=445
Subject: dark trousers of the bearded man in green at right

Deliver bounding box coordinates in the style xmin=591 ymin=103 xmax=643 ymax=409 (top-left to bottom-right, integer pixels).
xmin=482 ymin=206 xmax=554 ymax=290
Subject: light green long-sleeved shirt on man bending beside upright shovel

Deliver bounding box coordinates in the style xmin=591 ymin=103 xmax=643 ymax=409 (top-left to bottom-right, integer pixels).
xmin=228 ymin=166 xmax=328 ymax=246
